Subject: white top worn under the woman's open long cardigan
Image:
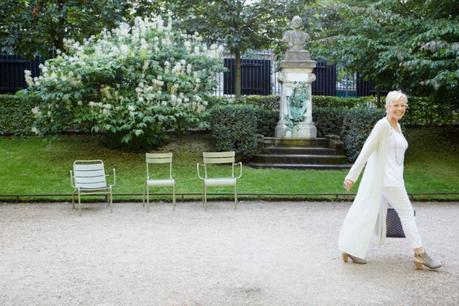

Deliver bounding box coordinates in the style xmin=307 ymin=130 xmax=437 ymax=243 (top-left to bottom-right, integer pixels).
xmin=384 ymin=129 xmax=408 ymax=187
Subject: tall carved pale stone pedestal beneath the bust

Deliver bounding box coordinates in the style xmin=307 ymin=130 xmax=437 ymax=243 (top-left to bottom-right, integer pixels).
xmin=275 ymin=59 xmax=317 ymax=139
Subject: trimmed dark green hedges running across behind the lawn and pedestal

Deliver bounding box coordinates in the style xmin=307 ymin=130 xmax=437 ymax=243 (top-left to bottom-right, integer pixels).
xmin=5 ymin=91 xmax=458 ymax=161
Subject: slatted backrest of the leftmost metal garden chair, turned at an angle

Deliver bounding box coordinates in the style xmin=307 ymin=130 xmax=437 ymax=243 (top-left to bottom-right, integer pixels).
xmin=73 ymin=160 xmax=107 ymax=189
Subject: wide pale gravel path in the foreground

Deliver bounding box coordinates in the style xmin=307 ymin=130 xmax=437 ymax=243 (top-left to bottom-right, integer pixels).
xmin=0 ymin=202 xmax=459 ymax=305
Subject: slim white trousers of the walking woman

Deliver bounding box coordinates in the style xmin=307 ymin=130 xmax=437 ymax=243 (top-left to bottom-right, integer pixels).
xmin=383 ymin=187 xmax=422 ymax=249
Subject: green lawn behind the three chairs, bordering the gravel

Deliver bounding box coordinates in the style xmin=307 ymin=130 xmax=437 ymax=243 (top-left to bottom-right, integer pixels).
xmin=0 ymin=128 xmax=459 ymax=200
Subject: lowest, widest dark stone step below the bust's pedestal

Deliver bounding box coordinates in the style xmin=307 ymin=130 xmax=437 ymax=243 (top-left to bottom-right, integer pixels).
xmin=254 ymin=154 xmax=348 ymax=164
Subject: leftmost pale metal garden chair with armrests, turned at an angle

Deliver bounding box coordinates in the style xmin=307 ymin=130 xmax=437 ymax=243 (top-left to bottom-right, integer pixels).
xmin=70 ymin=159 xmax=116 ymax=216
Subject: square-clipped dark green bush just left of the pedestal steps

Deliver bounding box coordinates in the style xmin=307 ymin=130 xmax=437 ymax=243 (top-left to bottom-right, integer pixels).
xmin=210 ymin=104 xmax=257 ymax=158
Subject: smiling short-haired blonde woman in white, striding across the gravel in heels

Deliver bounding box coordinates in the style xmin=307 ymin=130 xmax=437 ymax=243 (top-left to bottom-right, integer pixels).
xmin=339 ymin=91 xmax=441 ymax=269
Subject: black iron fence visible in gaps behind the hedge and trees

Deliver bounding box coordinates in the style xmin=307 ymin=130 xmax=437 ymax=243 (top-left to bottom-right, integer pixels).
xmin=0 ymin=51 xmax=376 ymax=97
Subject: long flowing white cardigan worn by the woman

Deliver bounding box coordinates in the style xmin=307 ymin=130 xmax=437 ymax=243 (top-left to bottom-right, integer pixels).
xmin=338 ymin=117 xmax=393 ymax=258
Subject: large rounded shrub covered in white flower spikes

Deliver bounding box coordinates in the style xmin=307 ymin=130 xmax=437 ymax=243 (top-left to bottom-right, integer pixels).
xmin=26 ymin=17 xmax=224 ymax=148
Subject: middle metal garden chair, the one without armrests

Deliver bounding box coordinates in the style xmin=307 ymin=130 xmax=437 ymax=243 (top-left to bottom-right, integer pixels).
xmin=142 ymin=153 xmax=176 ymax=211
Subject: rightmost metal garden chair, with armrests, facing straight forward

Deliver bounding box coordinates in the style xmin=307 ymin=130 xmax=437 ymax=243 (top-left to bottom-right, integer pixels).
xmin=196 ymin=151 xmax=242 ymax=209
